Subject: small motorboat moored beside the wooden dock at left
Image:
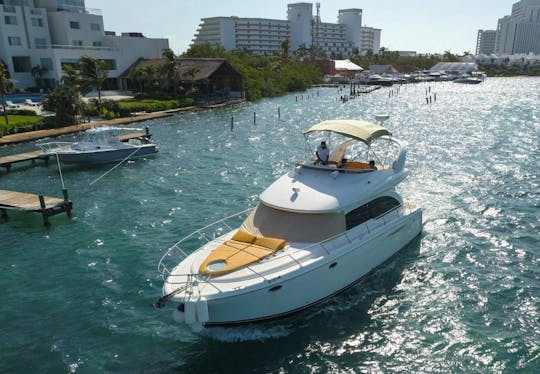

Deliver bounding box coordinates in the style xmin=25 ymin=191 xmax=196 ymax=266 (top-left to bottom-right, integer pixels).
xmin=38 ymin=128 xmax=158 ymax=164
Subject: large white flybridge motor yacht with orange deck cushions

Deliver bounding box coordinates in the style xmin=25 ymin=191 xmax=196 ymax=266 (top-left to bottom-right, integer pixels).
xmin=155 ymin=120 xmax=422 ymax=330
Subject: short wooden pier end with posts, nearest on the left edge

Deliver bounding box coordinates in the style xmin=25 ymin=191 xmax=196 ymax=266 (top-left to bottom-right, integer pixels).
xmin=0 ymin=189 xmax=73 ymax=225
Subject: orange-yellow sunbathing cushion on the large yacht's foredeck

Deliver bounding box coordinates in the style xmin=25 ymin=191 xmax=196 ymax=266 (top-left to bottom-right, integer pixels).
xmin=199 ymin=237 xmax=285 ymax=277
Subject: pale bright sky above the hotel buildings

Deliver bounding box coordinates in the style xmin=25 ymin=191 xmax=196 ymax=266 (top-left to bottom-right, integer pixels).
xmin=85 ymin=0 xmax=517 ymax=55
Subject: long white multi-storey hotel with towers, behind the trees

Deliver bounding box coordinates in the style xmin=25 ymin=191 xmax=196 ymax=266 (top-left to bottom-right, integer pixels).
xmin=193 ymin=3 xmax=380 ymax=56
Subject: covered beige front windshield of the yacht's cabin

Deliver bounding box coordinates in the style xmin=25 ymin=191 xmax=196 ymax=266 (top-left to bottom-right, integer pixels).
xmin=242 ymin=203 xmax=346 ymax=243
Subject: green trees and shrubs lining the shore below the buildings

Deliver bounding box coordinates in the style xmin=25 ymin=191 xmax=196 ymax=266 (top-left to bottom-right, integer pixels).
xmin=0 ymin=45 xmax=540 ymax=140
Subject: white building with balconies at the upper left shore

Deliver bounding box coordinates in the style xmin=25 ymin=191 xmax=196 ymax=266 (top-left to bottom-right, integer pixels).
xmin=0 ymin=0 xmax=169 ymax=89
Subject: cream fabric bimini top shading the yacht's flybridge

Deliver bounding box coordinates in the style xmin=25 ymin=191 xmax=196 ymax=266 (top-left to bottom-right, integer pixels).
xmin=304 ymin=119 xmax=392 ymax=145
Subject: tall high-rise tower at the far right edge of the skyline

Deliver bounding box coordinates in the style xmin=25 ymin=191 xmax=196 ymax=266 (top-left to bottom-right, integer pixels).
xmin=495 ymin=0 xmax=540 ymax=54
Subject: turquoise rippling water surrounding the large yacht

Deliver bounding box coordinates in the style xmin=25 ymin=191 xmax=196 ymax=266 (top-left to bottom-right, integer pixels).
xmin=0 ymin=78 xmax=540 ymax=373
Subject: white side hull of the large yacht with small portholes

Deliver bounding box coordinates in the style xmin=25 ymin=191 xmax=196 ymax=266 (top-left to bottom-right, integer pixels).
xmin=173 ymin=209 xmax=422 ymax=327
